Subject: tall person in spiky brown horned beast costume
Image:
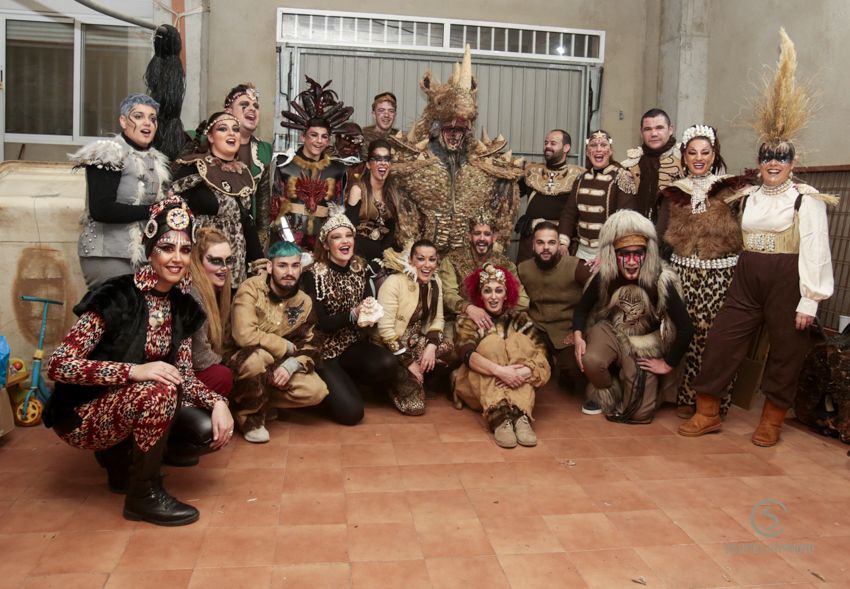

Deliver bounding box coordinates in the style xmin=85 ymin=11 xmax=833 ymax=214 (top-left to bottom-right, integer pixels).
xmin=391 ymin=45 xmax=523 ymax=255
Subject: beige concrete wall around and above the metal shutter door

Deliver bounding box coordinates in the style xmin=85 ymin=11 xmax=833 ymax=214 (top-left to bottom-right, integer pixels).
xmin=204 ymin=0 xmax=659 ymax=157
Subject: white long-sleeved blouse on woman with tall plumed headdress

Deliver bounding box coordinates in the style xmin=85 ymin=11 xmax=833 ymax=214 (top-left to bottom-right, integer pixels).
xmin=741 ymin=185 xmax=834 ymax=316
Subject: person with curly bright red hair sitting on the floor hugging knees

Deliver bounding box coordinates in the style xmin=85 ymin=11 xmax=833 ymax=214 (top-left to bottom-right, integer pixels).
xmin=454 ymin=264 xmax=551 ymax=448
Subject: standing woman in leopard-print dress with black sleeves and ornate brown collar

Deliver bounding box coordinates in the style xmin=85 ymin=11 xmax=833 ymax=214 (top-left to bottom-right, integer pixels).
xmin=172 ymin=112 xmax=263 ymax=287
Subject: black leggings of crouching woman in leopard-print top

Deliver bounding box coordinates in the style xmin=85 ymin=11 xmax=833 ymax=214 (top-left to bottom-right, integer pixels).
xmin=316 ymin=341 xmax=398 ymax=425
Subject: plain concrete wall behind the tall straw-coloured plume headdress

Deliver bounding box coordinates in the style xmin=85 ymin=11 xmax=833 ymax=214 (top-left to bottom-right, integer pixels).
xmin=704 ymin=0 xmax=850 ymax=172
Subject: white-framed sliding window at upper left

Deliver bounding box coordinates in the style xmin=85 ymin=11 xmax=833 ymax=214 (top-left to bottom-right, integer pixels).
xmin=5 ymin=19 xmax=153 ymax=142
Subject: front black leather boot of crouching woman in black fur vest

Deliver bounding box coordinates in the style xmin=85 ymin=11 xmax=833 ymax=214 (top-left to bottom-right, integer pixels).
xmin=124 ymin=436 xmax=200 ymax=526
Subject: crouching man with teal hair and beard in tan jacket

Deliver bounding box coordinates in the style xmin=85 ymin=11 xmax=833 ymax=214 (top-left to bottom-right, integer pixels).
xmin=229 ymin=241 xmax=328 ymax=443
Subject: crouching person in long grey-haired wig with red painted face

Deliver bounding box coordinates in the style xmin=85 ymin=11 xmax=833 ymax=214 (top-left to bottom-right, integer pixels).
xmin=573 ymin=210 xmax=693 ymax=423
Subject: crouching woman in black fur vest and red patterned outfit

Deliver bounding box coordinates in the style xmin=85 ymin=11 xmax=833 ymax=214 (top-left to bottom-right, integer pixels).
xmin=45 ymin=197 xmax=233 ymax=526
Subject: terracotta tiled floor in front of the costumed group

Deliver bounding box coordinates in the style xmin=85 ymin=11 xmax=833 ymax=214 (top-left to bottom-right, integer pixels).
xmin=0 ymin=386 xmax=850 ymax=589
